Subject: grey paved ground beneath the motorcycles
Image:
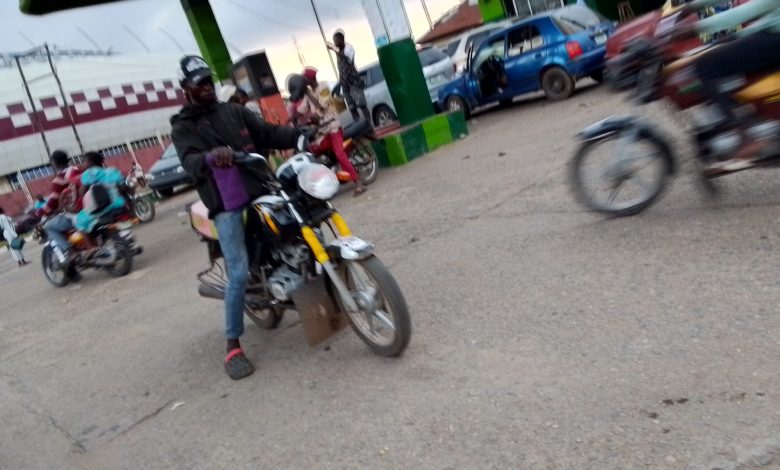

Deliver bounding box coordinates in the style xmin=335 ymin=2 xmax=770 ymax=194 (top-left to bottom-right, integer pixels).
xmin=0 ymin=82 xmax=780 ymax=470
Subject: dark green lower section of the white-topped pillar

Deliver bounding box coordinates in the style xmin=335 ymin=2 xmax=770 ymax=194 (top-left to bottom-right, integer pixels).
xmin=377 ymin=38 xmax=433 ymax=126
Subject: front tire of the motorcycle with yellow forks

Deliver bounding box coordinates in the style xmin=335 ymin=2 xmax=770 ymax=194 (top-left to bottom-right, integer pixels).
xmin=335 ymin=256 xmax=412 ymax=357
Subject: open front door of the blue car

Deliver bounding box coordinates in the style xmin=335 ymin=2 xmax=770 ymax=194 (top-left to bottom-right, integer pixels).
xmin=468 ymin=34 xmax=507 ymax=104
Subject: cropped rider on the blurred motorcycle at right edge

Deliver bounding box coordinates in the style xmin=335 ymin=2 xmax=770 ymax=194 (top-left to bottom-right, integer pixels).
xmin=672 ymin=0 xmax=780 ymax=173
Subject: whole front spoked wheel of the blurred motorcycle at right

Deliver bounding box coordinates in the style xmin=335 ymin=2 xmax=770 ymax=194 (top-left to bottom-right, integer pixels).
xmin=570 ymin=133 xmax=672 ymax=216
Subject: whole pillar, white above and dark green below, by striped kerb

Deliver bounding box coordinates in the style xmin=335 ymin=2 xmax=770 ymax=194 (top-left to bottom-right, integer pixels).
xmin=363 ymin=0 xmax=433 ymax=126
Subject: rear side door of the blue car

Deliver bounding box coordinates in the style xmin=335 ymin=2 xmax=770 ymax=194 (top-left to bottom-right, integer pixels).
xmin=505 ymin=23 xmax=547 ymax=95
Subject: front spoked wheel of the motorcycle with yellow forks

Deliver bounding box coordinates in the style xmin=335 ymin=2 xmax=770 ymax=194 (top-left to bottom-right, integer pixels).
xmin=336 ymin=256 xmax=412 ymax=357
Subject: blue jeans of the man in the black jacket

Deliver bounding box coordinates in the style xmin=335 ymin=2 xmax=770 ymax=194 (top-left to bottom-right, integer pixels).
xmin=214 ymin=210 xmax=249 ymax=339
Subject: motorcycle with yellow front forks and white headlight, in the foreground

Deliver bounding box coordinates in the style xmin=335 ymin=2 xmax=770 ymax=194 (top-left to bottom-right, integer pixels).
xmin=187 ymin=137 xmax=412 ymax=357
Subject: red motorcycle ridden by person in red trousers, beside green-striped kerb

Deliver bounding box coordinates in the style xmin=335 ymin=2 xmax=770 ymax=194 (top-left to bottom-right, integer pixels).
xmin=309 ymin=119 xmax=379 ymax=185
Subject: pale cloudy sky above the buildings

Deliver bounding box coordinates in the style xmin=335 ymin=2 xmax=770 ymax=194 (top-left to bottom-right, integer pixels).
xmin=0 ymin=0 xmax=459 ymax=85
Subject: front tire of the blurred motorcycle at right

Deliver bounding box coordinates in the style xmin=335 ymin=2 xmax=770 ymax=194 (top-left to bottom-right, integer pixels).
xmin=569 ymin=133 xmax=672 ymax=217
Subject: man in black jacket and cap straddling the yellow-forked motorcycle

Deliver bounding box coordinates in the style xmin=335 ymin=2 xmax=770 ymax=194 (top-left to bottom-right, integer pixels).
xmin=171 ymin=56 xmax=299 ymax=380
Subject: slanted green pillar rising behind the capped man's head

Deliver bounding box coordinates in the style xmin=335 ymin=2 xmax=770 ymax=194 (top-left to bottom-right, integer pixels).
xmin=181 ymin=0 xmax=233 ymax=81
